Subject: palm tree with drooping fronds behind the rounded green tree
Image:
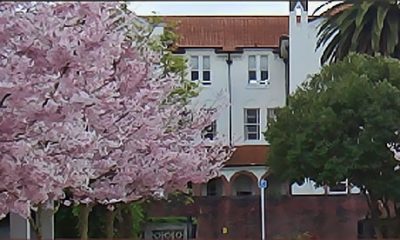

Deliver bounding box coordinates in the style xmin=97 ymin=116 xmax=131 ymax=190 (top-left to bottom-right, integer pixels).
xmin=316 ymin=0 xmax=400 ymax=64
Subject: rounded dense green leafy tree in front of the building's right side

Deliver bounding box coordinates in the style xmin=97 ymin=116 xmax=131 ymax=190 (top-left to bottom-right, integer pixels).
xmin=265 ymin=55 xmax=400 ymax=238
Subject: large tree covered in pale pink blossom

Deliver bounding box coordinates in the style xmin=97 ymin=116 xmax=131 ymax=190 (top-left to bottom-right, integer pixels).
xmin=0 ymin=3 xmax=232 ymax=238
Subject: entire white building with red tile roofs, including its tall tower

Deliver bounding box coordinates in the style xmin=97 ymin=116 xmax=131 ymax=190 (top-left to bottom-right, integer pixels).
xmin=153 ymin=0 xmax=359 ymax=196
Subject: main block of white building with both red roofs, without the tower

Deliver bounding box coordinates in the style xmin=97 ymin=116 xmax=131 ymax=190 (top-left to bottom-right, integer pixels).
xmin=161 ymin=16 xmax=288 ymax=196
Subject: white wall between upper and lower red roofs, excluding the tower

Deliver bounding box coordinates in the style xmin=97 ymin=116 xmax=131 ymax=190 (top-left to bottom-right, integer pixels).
xmin=184 ymin=49 xmax=286 ymax=146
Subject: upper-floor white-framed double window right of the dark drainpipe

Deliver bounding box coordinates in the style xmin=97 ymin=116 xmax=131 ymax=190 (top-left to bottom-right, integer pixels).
xmin=248 ymin=55 xmax=269 ymax=85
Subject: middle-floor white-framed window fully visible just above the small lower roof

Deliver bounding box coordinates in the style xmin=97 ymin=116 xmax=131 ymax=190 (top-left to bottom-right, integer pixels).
xmin=244 ymin=108 xmax=261 ymax=140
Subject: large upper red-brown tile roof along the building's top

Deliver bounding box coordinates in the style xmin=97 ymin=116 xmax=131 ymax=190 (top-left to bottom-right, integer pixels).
xmin=164 ymin=16 xmax=289 ymax=51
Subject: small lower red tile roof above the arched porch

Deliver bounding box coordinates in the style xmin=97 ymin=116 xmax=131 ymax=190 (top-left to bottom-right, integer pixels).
xmin=226 ymin=145 xmax=269 ymax=166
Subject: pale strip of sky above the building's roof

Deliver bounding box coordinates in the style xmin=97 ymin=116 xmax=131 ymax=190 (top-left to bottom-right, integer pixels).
xmin=129 ymin=1 xmax=342 ymax=15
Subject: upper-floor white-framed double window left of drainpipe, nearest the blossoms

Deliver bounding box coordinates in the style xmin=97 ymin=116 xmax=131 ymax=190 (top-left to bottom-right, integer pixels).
xmin=190 ymin=56 xmax=211 ymax=85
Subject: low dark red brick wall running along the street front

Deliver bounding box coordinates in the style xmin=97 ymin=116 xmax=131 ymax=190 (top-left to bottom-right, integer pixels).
xmin=148 ymin=195 xmax=367 ymax=240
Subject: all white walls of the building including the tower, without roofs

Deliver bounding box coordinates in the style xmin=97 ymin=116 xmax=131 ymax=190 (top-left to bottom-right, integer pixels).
xmin=160 ymin=6 xmax=359 ymax=195
